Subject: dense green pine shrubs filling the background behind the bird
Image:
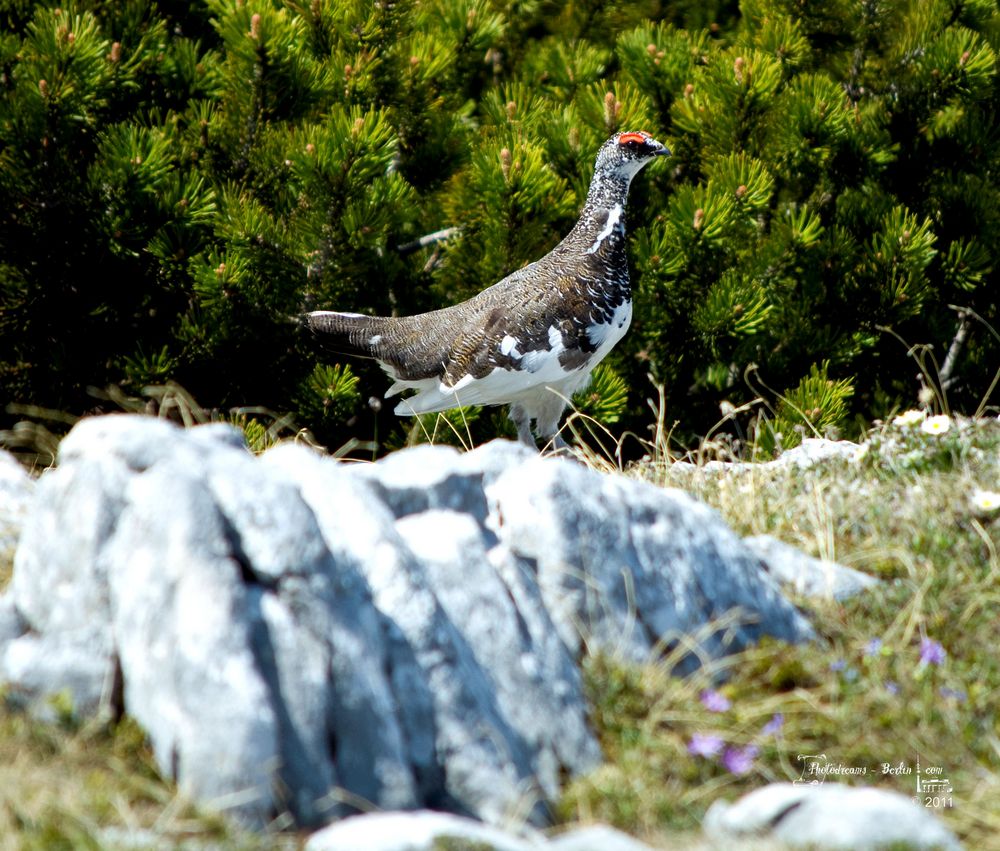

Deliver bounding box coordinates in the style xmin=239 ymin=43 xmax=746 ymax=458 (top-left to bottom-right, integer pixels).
xmin=0 ymin=0 xmax=1000 ymax=452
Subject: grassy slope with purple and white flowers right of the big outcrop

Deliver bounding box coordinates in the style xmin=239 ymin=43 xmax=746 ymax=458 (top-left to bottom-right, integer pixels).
xmin=564 ymin=419 xmax=1000 ymax=849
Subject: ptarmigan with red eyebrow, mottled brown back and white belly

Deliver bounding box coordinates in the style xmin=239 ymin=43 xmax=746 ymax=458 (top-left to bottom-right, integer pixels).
xmin=306 ymin=131 xmax=670 ymax=448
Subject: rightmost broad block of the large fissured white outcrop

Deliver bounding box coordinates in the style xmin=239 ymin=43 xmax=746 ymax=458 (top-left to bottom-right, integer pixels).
xmin=487 ymin=457 xmax=812 ymax=670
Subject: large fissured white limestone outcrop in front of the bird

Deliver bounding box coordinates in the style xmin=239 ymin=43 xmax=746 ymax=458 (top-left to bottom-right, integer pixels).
xmin=0 ymin=415 xmax=813 ymax=828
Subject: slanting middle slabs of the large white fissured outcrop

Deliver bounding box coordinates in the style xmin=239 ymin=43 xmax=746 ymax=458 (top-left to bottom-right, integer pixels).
xmin=264 ymin=447 xmax=600 ymax=821
